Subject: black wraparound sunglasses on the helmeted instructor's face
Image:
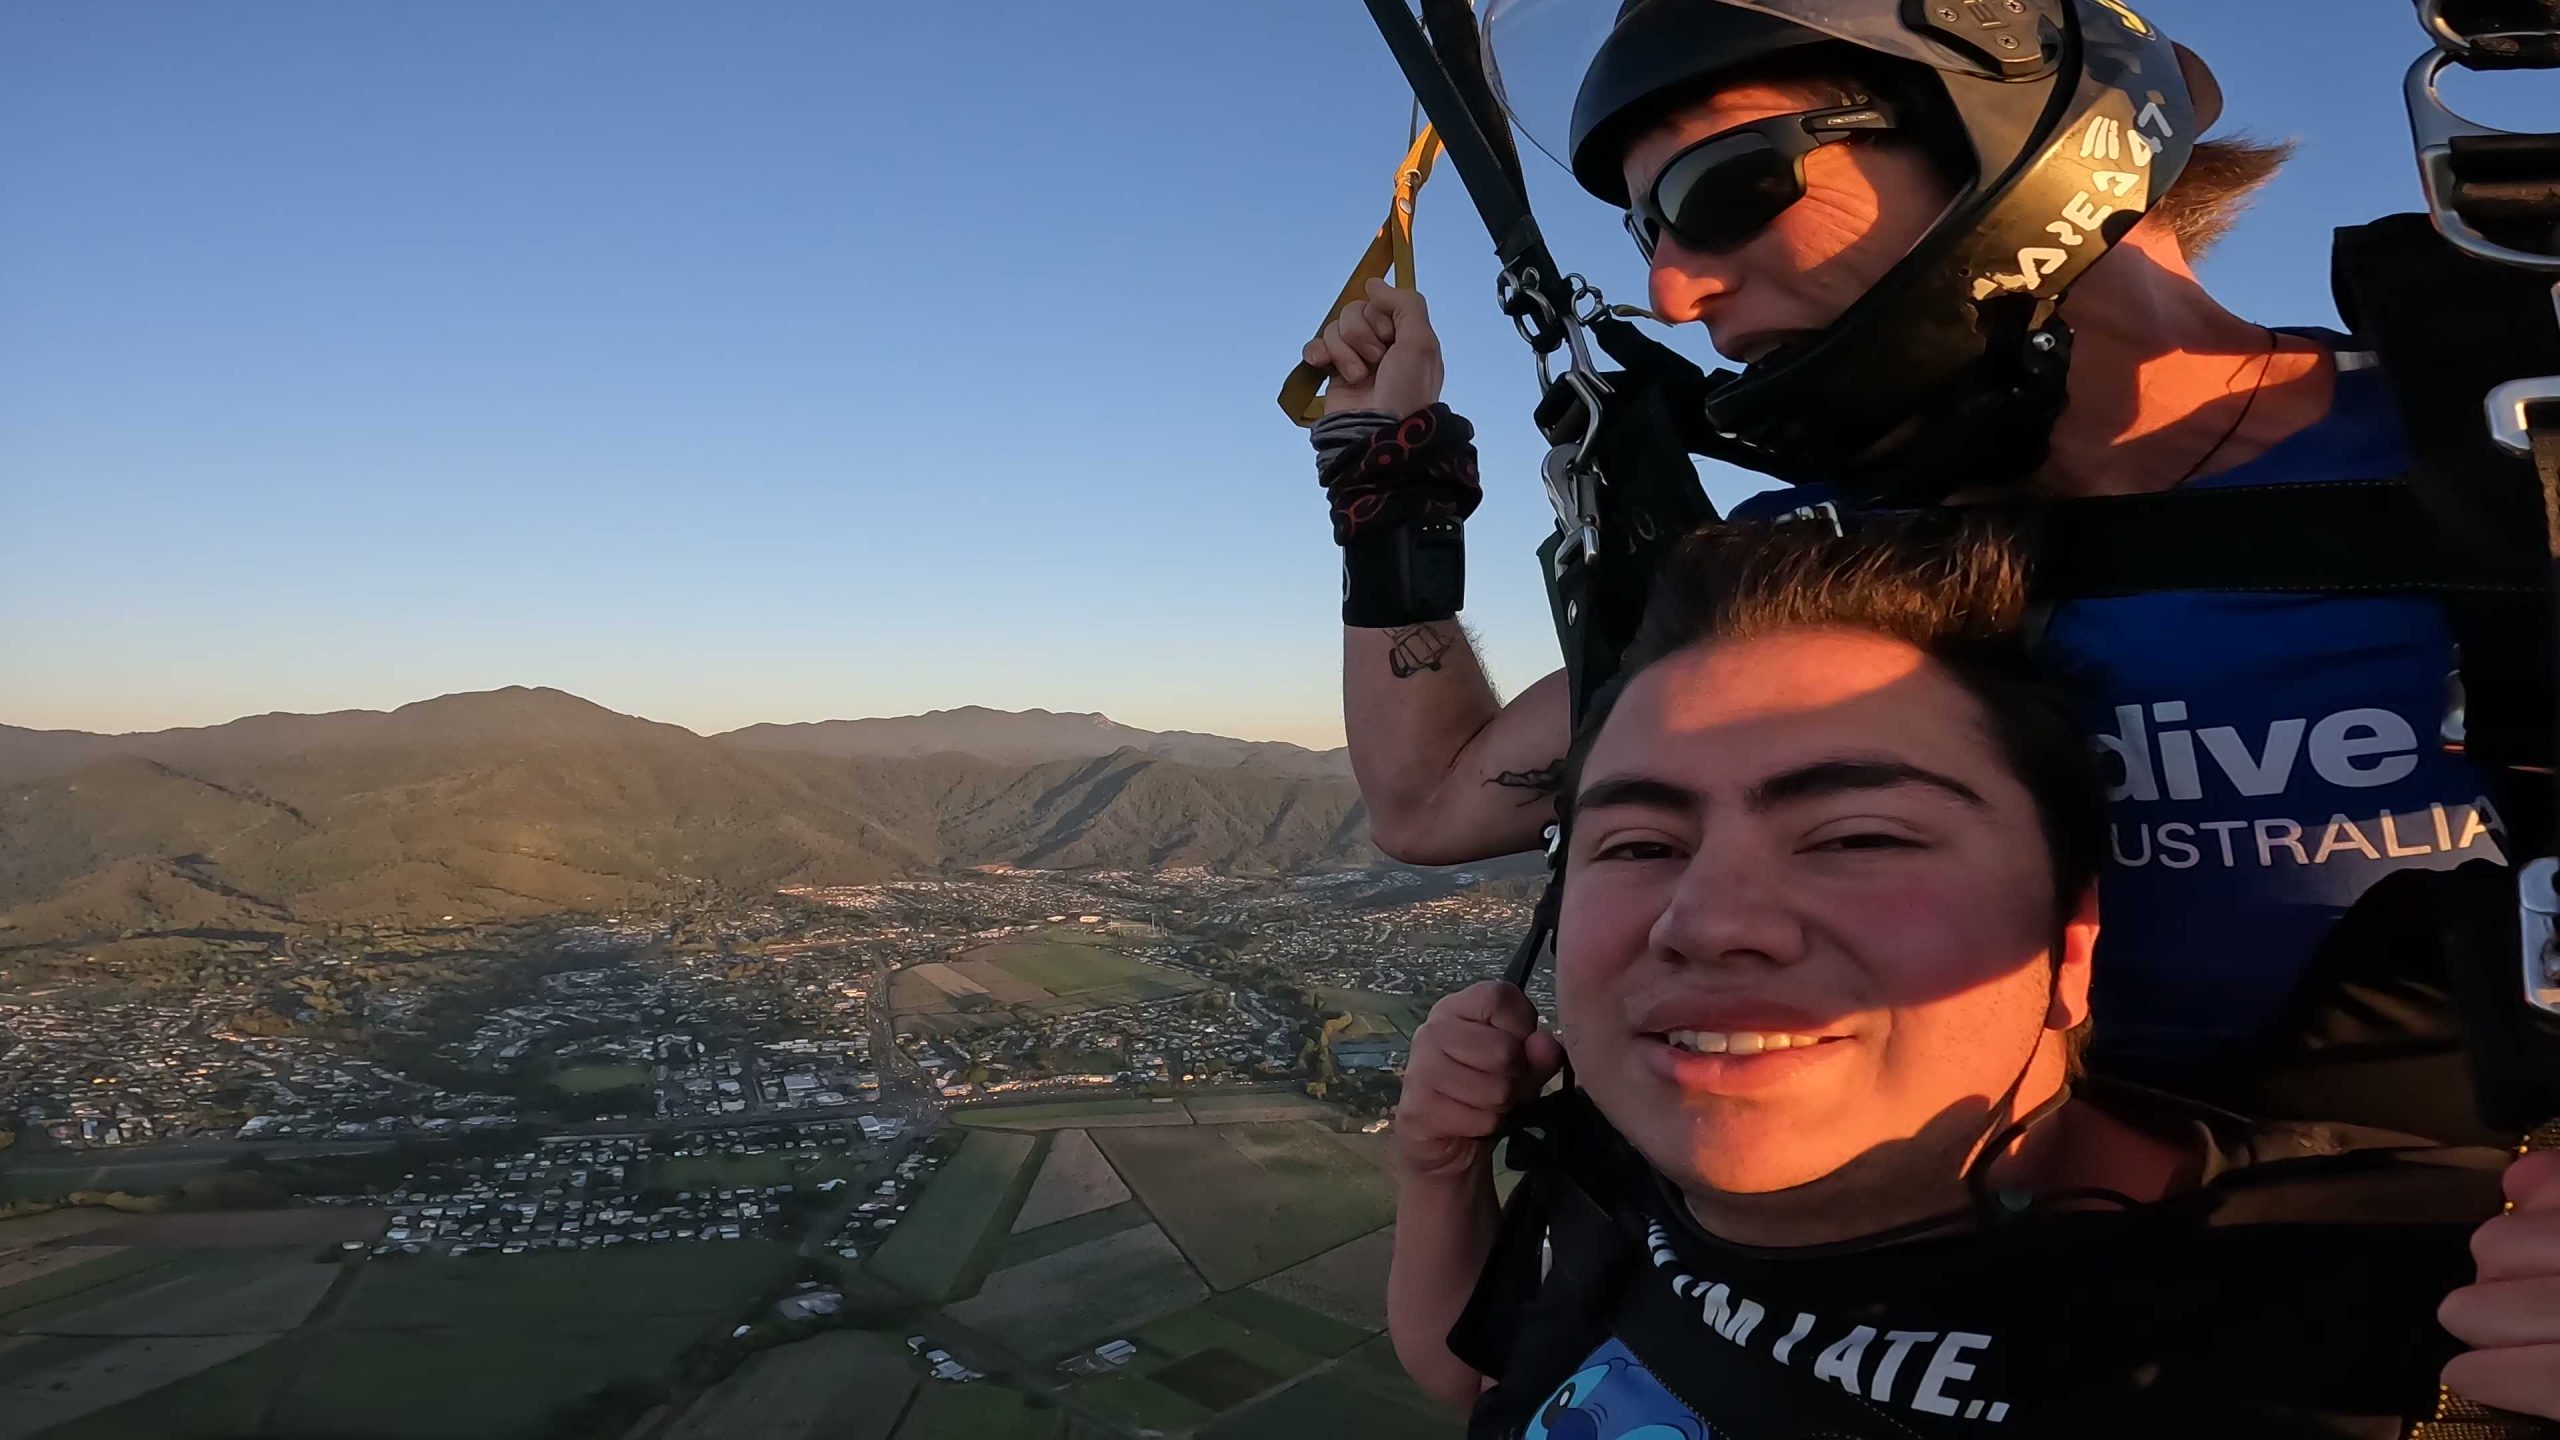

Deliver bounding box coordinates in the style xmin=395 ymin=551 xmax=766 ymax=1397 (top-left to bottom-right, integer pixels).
xmin=1626 ymin=100 xmax=1897 ymax=264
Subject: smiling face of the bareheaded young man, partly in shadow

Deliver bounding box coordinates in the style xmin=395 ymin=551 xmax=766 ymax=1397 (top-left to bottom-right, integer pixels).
xmin=1556 ymin=630 xmax=2094 ymax=1197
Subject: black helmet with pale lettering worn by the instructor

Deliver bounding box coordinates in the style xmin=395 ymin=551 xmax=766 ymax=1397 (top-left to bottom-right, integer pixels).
xmin=1569 ymin=0 xmax=2220 ymax=500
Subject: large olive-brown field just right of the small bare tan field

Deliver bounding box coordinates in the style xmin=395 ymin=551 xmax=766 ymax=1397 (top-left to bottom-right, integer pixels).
xmin=1093 ymin=1122 xmax=1395 ymax=1289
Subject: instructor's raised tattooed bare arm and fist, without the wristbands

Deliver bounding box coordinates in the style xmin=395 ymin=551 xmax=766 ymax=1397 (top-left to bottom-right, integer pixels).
xmin=1306 ymin=279 xmax=1567 ymax=866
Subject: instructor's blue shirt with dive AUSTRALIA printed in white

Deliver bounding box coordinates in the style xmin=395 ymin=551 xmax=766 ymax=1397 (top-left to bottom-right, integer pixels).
xmin=1736 ymin=354 xmax=2504 ymax=1063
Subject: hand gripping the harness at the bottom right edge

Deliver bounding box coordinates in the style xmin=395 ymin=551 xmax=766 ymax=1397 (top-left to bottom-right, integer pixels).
xmin=2447 ymin=1142 xmax=2560 ymax=1420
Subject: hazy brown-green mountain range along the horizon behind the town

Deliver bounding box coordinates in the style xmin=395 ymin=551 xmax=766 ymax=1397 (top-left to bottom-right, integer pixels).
xmin=0 ymin=687 xmax=1377 ymax=945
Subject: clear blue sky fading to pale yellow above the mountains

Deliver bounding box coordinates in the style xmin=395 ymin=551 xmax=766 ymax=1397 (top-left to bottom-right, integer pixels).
xmin=0 ymin=0 xmax=2519 ymax=743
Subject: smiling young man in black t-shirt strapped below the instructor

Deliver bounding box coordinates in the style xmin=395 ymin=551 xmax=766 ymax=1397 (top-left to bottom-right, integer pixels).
xmin=1388 ymin=525 xmax=2560 ymax=1440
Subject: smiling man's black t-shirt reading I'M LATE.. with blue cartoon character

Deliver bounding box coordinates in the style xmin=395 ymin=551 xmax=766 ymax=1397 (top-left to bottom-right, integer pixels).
xmin=1459 ymin=1086 xmax=2504 ymax=1440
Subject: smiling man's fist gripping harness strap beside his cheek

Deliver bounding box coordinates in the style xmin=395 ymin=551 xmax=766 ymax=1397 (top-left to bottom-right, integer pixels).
xmin=1395 ymin=979 xmax=1564 ymax=1179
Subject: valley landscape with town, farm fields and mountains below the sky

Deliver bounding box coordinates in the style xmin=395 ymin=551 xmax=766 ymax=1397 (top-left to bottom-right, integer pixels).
xmin=0 ymin=692 xmax=1533 ymax=1440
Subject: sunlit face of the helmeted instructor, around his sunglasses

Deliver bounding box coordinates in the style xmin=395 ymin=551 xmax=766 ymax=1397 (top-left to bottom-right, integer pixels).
xmin=1626 ymin=85 xmax=1953 ymax=364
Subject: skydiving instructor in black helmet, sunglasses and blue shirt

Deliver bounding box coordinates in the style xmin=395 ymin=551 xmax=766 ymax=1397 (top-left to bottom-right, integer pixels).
xmin=1306 ymin=0 xmax=2504 ymax=1135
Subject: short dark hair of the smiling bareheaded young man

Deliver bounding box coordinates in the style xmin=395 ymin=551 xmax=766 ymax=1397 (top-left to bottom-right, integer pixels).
xmin=1559 ymin=515 xmax=2107 ymax=928
